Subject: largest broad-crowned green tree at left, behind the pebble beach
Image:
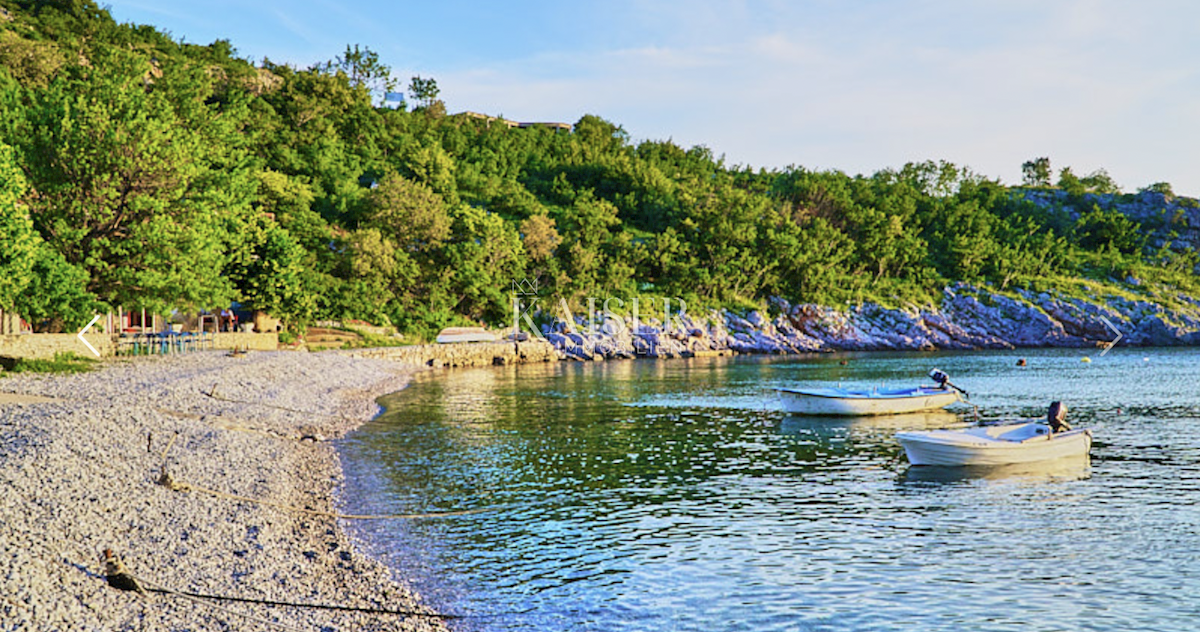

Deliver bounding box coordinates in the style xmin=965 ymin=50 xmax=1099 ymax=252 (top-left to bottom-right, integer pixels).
xmin=13 ymin=52 xmax=253 ymax=308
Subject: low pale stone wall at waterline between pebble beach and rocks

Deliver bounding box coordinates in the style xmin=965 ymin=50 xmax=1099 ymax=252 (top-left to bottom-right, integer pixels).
xmin=348 ymin=339 xmax=563 ymax=368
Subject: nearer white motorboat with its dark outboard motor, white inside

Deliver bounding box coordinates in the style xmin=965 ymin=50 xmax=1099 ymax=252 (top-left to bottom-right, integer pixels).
xmin=896 ymin=402 xmax=1092 ymax=465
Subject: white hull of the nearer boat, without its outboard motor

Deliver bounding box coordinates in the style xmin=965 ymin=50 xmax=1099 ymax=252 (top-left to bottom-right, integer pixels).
xmin=896 ymin=425 xmax=1092 ymax=465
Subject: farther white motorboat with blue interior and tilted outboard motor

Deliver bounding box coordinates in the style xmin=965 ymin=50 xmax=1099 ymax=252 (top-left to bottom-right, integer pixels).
xmin=776 ymin=368 xmax=967 ymax=415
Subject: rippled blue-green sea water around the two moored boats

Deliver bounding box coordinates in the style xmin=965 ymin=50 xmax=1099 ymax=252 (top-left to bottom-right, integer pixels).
xmin=340 ymin=349 xmax=1200 ymax=632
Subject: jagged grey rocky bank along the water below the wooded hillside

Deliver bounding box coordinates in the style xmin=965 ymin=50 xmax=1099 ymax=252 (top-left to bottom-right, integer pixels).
xmin=542 ymin=283 xmax=1200 ymax=360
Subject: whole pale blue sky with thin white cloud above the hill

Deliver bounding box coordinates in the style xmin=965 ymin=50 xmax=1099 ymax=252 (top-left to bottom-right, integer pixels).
xmin=102 ymin=0 xmax=1200 ymax=197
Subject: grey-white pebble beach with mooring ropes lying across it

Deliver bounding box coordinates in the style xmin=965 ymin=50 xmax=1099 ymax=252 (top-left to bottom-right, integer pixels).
xmin=0 ymin=351 xmax=444 ymax=632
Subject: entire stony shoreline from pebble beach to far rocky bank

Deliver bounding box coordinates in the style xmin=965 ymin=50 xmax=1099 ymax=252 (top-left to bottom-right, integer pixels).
xmin=0 ymin=284 xmax=1200 ymax=632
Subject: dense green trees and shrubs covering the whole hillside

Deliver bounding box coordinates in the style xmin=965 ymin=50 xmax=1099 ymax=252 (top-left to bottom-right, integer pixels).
xmin=0 ymin=0 xmax=1198 ymax=335
